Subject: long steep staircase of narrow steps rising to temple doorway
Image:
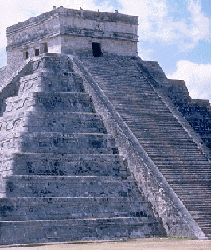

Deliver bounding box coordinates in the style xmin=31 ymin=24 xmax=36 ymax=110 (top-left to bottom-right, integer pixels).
xmin=80 ymin=56 xmax=211 ymax=237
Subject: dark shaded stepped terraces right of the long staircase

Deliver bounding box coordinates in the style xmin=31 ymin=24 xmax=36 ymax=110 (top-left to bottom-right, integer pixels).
xmin=139 ymin=60 xmax=211 ymax=157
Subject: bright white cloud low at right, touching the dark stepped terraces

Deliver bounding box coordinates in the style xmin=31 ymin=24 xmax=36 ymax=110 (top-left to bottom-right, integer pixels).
xmin=167 ymin=60 xmax=211 ymax=102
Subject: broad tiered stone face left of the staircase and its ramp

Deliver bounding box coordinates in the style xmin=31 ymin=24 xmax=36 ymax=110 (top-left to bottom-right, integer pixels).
xmin=0 ymin=54 xmax=165 ymax=245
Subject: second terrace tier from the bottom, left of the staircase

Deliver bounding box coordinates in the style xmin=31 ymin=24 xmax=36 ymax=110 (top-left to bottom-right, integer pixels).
xmin=0 ymin=196 xmax=153 ymax=221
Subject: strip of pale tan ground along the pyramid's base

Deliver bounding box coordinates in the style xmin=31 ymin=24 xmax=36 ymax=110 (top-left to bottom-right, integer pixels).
xmin=2 ymin=238 xmax=211 ymax=250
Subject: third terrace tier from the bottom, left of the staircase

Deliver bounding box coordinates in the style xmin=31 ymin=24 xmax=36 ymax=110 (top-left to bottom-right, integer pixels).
xmin=1 ymin=175 xmax=139 ymax=197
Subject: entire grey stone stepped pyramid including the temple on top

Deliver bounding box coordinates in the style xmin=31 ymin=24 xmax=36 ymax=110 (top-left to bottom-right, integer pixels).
xmin=0 ymin=7 xmax=211 ymax=245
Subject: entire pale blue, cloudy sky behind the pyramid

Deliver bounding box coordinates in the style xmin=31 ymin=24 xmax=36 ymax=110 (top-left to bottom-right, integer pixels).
xmin=0 ymin=0 xmax=211 ymax=102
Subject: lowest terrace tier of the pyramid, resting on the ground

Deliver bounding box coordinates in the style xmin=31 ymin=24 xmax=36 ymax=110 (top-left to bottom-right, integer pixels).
xmin=0 ymin=217 xmax=166 ymax=245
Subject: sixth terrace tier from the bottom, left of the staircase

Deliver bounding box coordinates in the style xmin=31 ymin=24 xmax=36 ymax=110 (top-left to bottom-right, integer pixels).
xmin=0 ymin=112 xmax=107 ymax=133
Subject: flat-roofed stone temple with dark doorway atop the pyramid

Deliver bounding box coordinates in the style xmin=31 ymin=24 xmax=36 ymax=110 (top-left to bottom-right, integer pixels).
xmin=7 ymin=6 xmax=138 ymax=71
